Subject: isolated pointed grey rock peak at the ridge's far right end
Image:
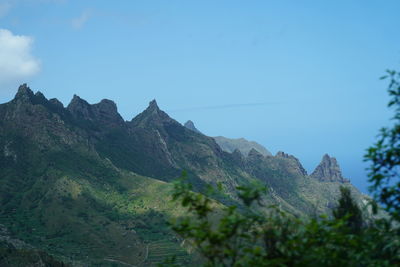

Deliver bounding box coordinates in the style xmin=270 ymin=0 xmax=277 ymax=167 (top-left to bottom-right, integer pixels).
xmin=311 ymin=154 xmax=349 ymax=183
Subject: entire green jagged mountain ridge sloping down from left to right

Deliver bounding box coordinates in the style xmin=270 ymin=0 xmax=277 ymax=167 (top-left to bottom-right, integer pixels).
xmin=0 ymin=84 xmax=364 ymax=266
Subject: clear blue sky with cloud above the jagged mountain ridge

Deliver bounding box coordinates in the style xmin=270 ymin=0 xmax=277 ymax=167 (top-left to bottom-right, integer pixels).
xmin=0 ymin=0 xmax=400 ymax=192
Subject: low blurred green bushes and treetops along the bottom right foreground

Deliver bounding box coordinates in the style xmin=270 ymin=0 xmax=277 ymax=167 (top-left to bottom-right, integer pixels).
xmin=168 ymin=174 xmax=400 ymax=266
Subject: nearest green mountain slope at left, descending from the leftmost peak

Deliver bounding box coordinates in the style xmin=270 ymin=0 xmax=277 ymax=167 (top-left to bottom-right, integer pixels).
xmin=0 ymin=86 xmax=192 ymax=265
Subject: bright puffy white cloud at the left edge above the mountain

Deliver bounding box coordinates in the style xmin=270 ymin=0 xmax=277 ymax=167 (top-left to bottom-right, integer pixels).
xmin=0 ymin=29 xmax=40 ymax=85
